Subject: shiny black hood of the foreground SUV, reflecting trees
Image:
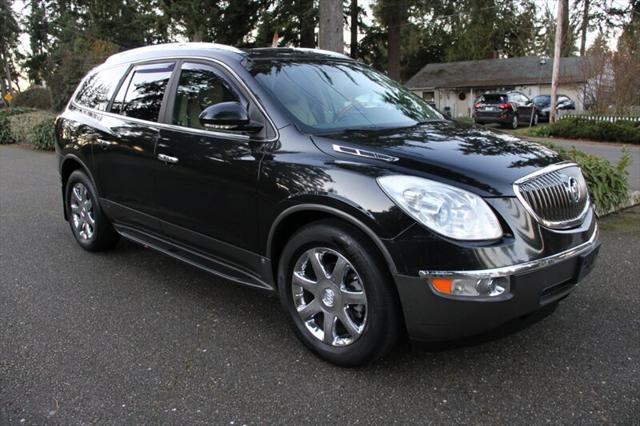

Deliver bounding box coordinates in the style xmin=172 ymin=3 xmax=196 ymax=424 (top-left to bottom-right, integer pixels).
xmin=312 ymin=121 xmax=562 ymax=197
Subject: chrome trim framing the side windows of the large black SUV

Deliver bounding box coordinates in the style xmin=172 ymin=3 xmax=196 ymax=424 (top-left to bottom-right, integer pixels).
xmin=69 ymin=55 xmax=280 ymax=143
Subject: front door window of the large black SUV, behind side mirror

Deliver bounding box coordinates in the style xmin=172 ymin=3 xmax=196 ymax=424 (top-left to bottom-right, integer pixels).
xmin=173 ymin=64 xmax=238 ymax=129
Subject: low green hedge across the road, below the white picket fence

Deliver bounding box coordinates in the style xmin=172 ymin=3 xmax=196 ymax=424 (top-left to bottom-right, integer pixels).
xmin=529 ymin=118 xmax=640 ymax=144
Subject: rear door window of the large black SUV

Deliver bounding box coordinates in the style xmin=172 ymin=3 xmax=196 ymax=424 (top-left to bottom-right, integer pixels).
xmin=111 ymin=63 xmax=175 ymax=121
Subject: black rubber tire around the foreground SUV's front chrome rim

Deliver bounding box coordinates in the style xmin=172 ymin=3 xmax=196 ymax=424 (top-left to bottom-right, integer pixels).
xmin=278 ymin=219 xmax=402 ymax=367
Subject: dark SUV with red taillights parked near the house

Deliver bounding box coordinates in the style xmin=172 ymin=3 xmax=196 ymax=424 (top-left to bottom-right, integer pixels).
xmin=473 ymin=91 xmax=538 ymax=129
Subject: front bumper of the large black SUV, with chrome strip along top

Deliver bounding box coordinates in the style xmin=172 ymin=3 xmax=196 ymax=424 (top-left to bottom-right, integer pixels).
xmin=395 ymin=228 xmax=600 ymax=341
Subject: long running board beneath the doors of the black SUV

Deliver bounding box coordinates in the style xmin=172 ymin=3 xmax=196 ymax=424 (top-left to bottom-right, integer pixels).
xmin=113 ymin=224 xmax=274 ymax=291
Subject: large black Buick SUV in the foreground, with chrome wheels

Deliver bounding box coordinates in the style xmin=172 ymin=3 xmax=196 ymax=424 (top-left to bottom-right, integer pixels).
xmin=56 ymin=44 xmax=598 ymax=365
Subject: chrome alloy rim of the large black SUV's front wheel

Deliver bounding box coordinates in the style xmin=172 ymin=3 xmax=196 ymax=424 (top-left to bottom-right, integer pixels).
xmin=291 ymin=248 xmax=367 ymax=346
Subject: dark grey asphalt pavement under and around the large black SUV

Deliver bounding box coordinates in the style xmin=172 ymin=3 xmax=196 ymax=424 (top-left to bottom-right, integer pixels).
xmin=0 ymin=147 xmax=640 ymax=425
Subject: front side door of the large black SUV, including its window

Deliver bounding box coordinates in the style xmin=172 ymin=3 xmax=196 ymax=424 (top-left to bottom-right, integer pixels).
xmin=156 ymin=62 xmax=264 ymax=257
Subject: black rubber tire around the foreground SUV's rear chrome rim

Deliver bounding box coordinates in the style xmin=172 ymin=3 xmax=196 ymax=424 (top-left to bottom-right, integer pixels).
xmin=64 ymin=170 xmax=119 ymax=251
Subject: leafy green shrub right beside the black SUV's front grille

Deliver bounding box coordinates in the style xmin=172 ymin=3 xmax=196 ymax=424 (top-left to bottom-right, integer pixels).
xmin=544 ymin=143 xmax=631 ymax=214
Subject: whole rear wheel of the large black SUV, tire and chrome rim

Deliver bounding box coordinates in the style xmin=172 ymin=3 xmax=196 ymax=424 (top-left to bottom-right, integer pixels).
xmin=65 ymin=170 xmax=118 ymax=251
